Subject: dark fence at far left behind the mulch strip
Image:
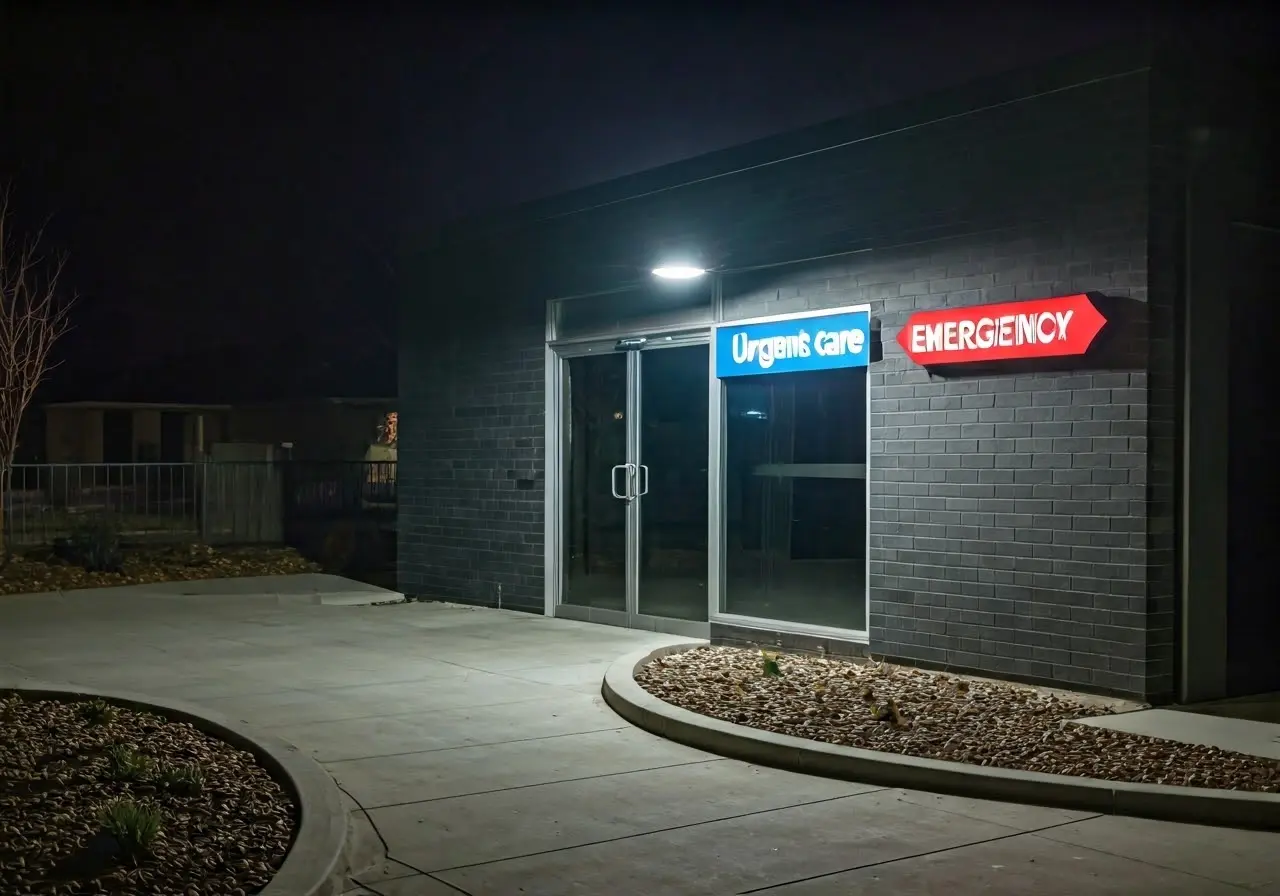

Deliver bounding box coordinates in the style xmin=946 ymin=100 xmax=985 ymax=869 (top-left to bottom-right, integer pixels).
xmin=4 ymin=461 xmax=396 ymax=547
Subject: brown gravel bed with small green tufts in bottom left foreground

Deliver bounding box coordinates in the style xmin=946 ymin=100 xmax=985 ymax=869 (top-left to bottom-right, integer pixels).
xmin=0 ymin=694 xmax=298 ymax=896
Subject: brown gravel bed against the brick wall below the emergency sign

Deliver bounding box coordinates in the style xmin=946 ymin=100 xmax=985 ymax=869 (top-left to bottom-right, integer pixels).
xmin=636 ymin=648 xmax=1280 ymax=794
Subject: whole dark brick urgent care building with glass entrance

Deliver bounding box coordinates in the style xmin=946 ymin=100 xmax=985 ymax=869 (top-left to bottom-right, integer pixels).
xmin=398 ymin=36 xmax=1280 ymax=701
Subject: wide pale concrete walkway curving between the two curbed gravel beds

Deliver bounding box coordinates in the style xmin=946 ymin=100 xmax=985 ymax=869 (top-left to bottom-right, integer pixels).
xmin=0 ymin=590 xmax=1280 ymax=896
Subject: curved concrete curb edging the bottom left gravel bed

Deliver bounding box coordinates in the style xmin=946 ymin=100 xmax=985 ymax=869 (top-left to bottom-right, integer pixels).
xmin=0 ymin=678 xmax=348 ymax=896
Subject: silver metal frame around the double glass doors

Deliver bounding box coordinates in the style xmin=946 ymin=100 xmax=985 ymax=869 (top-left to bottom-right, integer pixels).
xmin=544 ymin=326 xmax=719 ymax=639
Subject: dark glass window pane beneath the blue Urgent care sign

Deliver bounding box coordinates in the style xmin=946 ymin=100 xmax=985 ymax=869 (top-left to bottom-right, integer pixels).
xmin=724 ymin=367 xmax=868 ymax=631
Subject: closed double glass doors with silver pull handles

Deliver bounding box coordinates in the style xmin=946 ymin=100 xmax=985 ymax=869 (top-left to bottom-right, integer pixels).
xmin=557 ymin=338 xmax=709 ymax=635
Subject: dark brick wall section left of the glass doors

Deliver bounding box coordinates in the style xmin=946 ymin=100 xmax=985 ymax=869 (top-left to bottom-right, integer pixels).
xmin=398 ymin=293 xmax=545 ymax=611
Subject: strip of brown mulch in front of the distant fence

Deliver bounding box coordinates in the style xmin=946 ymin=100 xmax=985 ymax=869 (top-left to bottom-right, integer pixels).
xmin=0 ymin=544 xmax=320 ymax=594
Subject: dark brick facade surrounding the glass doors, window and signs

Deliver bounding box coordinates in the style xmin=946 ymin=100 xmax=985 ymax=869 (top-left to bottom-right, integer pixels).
xmin=399 ymin=54 xmax=1172 ymax=695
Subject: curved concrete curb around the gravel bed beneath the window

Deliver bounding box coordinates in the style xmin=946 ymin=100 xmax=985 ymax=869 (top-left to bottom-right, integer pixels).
xmin=602 ymin=641 xmax=1280 ymax=831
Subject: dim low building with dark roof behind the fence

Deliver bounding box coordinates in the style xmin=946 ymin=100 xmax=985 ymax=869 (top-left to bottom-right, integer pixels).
xmin=38 ymin=337 xmax=396 ymax=463
